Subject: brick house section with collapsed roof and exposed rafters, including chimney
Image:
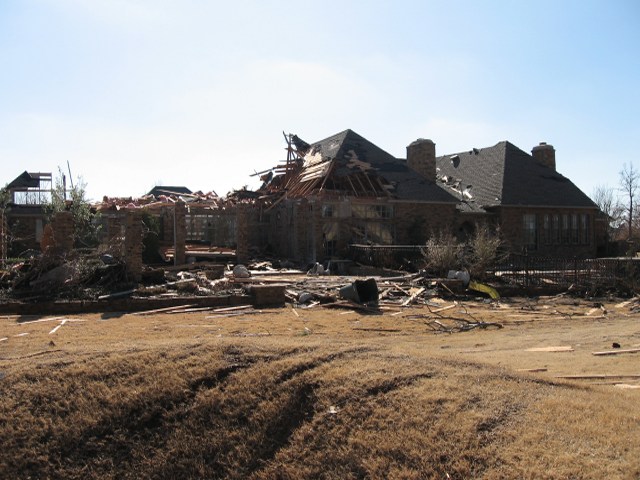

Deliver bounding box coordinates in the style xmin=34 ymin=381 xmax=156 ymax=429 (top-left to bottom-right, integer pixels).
xmin=255 ymin=130 xmax=458 ymax=262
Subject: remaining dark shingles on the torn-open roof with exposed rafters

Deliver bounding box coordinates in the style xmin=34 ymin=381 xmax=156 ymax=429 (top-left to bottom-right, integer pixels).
xmin=309 ymin=130 xmax=457 ymax=203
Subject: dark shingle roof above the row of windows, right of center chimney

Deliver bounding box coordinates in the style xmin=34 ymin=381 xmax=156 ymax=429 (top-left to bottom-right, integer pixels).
xmin=436 ymin=141 xmax=596 ymax=211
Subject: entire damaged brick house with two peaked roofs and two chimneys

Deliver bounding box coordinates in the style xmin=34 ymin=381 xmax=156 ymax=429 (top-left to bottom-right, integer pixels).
xmin=254 ymin=130 xmax=599 ymax=262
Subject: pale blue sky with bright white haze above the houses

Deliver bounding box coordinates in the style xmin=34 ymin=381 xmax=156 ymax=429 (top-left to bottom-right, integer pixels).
xmin=0 ymin=0 xmax=640 ymax=200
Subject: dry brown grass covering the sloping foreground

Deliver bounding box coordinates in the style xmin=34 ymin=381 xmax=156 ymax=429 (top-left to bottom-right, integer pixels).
xmin=0 ymin=301 xmax=640 ymax=479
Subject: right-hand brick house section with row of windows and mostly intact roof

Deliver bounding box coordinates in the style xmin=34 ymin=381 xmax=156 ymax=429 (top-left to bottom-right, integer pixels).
xmin=432 ymin=141 xmax=604 ymax=257
